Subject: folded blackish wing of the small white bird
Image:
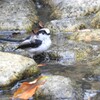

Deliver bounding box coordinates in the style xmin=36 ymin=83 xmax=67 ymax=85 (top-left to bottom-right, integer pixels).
xmin=17 ymin=39 xmax=42 ymax=49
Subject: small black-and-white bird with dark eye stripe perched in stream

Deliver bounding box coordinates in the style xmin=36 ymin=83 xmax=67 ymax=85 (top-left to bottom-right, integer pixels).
xmin=16 ymin=23 xmax=51 ymax=56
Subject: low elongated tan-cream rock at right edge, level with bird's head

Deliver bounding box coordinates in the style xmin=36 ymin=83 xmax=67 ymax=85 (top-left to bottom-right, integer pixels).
xmin=69 ymin=29 xmax=100 ymax=42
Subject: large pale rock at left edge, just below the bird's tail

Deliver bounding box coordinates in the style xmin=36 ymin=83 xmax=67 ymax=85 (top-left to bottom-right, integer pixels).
xmin=0 ymin=52 xmax=39 ymax=86
